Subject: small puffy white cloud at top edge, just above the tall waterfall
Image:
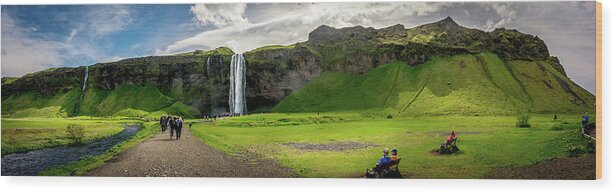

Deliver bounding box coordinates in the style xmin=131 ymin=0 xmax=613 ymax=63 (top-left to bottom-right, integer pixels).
xmin=190 ymin=3 xmax=248 ymax=27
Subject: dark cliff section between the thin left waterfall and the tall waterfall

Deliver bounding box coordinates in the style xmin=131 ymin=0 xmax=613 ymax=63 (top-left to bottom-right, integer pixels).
xmin=90 ymin=53 xmax=231 ymax=114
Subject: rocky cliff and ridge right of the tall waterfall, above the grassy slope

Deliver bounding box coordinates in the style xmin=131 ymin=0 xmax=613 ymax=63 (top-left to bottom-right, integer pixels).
xmin=245 ymin=17 xmax=552 ymax=109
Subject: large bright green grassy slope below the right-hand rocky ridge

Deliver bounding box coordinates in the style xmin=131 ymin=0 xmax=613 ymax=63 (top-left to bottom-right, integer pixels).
xmin=273 ymin=53 xmax=595 ymax=116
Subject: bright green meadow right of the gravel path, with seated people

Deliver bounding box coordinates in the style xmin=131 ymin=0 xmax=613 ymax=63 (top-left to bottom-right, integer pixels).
xmin=191 ymin=113 xmax=592 ymax=178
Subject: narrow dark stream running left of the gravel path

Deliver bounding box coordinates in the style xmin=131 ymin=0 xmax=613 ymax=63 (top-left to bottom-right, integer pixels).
xmin=2 ymin=125 xmax=139 ymax=176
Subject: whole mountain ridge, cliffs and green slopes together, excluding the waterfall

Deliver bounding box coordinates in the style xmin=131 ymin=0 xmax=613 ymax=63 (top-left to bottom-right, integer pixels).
xmin=2 ymin=17 xmax=595 ymax=116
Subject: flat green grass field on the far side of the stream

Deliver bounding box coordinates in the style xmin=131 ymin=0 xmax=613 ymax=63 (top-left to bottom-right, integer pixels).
xmin=2 ymin=117 xmax=140 ymax=155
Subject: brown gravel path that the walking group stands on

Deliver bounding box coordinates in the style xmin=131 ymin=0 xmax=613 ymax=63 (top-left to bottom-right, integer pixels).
xmin=84 ymin=128 xmax=294 ymax=177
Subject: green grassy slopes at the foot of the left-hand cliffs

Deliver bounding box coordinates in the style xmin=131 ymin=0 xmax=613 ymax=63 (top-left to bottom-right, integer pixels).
xmin=2 ymin=84 xmax=199 ymax=117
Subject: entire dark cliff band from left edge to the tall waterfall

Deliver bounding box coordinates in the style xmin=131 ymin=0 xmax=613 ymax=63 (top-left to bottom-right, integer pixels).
xmin=2 ymin=48 xmax=233 ymax=115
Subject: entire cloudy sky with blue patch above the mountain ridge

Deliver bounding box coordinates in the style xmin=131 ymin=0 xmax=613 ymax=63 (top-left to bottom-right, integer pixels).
xmin=1 ymin=2 xmax=596 ymax=93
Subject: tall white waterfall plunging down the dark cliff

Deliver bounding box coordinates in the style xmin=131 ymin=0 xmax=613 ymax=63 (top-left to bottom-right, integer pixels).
xmin=229 ymin=54 xmax=247 ymax=116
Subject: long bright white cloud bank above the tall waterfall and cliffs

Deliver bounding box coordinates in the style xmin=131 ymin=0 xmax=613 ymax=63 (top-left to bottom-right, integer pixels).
xmin=164 ymin=2 xmax=449 ymax=54
